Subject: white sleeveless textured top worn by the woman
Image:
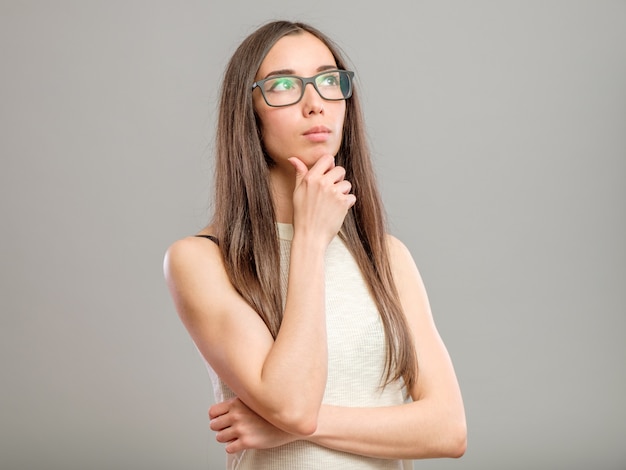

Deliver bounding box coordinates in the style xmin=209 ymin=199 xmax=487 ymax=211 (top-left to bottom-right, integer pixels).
xmin=207 ymin=223 xmax=413 ymax=470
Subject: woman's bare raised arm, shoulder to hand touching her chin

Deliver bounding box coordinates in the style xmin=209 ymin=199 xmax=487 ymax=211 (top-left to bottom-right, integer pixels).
xmin=164 ymin=158 xmax=354 ymax=435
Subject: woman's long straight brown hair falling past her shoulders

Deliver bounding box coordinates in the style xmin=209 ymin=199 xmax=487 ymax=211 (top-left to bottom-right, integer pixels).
xmin=213 ymin=21 xmax=417 ymax=390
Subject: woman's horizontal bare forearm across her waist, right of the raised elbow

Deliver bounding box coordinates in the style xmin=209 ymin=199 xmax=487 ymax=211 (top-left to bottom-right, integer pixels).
xmin=308 ymin=400 xmax=466 ymax=459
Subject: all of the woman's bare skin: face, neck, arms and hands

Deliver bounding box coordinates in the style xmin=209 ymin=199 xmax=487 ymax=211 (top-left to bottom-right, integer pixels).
xmin=165 ymin=33 xmax=466 ymax=458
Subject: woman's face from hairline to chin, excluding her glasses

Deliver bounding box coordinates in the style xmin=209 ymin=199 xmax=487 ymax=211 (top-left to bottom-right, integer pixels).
xmin=253 ymin=33 xmax=346 ymax=168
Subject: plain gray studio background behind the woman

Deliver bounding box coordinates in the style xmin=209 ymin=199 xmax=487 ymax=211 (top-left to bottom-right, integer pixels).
xmin=0 ymin=0 xmax=626 ymax=470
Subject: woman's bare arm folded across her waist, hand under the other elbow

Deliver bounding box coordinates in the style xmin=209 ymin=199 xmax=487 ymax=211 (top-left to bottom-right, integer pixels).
xmin=209 ymin=233 xmax=466 ymax=459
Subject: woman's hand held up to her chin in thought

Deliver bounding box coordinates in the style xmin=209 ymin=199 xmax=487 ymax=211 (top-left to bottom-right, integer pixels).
xmin=289 ymin=155 xmax=356 ymax=243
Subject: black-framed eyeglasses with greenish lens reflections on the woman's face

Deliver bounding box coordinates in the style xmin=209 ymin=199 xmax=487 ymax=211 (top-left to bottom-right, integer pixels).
xmin=252 ymin=70 xmax=354 ymax=108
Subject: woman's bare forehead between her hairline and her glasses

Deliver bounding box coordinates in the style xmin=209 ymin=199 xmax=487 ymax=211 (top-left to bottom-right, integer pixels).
xmin=257 ymin=32 xmax=337 ymax=79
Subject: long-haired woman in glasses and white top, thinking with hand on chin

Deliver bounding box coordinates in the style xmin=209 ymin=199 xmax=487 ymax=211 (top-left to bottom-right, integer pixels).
xmin=165 ymin=21 xmax=466 ymax=470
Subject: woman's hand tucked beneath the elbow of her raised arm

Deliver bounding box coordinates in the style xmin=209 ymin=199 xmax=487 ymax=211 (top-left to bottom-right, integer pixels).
xmin=209 ymin=398 xmax=297 ymax=454
